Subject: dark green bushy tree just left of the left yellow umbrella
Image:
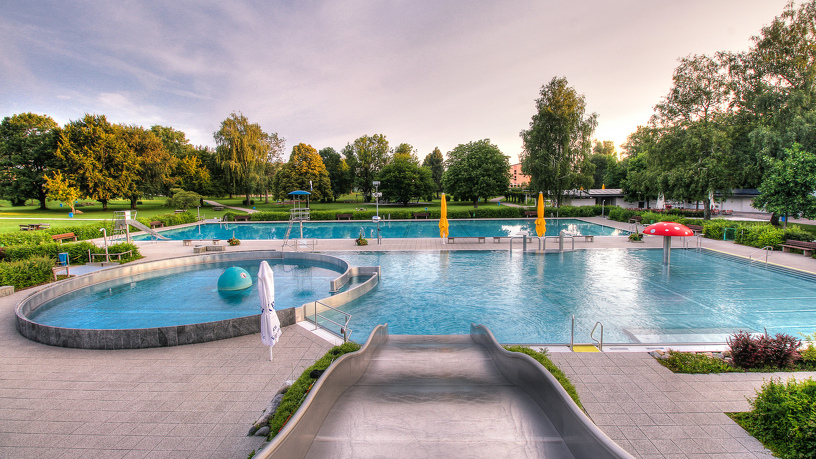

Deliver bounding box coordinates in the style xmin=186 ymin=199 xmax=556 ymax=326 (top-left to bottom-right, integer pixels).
xmin=380 ymin=148 xmax=436 ymax=206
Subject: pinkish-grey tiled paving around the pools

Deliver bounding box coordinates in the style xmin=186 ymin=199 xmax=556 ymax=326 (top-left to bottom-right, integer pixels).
xmin=0 ymin=218 xmax=816 ymax=459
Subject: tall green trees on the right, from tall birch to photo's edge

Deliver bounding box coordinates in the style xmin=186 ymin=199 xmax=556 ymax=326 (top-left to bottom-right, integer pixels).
xmin=521 ymin=0 xmax=816 ymax=218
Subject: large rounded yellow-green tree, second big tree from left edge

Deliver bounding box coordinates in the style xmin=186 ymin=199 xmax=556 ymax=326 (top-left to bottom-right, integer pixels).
xmin=56 ymin=115 xmax=139 ymax=210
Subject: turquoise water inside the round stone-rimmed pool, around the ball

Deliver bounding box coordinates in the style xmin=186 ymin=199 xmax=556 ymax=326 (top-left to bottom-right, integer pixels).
xmin=29 ymin=260 xmax=340 ymax=329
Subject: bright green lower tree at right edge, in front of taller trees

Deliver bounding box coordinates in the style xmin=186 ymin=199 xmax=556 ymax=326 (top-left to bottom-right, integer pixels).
xmin=753 ymin=144 xmax=816 ymax=227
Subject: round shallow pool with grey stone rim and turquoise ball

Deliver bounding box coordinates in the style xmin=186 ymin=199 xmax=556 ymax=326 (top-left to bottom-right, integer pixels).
xmin=16 ymin=251 xmax=379 ymax=349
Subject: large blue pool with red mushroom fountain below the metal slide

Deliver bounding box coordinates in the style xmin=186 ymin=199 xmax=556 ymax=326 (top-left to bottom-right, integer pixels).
xmin=318 ymin=249 xmax=816 ymax=343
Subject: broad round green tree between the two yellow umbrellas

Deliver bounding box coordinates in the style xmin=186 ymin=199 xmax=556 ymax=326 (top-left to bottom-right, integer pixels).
xmin=442 ymin=139 xmax=510 ymax=207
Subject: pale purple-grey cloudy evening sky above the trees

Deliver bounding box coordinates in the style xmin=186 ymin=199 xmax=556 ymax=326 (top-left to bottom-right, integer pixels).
xmin=0 ymin=0 xmax=787 ymax=163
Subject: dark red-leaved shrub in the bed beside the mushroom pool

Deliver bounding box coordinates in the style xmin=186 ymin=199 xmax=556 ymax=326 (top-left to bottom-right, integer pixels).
xmin=728 ymin=330 xmax=801 ymax=369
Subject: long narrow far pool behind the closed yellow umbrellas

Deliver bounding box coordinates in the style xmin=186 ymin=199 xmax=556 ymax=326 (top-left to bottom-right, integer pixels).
xmin=133 ymin=218 xmax=629 ymax=240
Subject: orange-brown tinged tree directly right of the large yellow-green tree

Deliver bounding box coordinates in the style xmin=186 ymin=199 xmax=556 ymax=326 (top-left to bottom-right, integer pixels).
xmin=119 ymin=126 xmax=176 ymax=209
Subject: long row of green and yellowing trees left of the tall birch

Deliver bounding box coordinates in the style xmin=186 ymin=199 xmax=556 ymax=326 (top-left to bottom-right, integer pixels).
xmin=0 ymin=108 xmax=509 ymax=210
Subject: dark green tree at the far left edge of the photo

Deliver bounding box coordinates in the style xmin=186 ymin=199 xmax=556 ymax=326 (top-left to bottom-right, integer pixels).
xmin=0 ymin=113 xmax=59 ymax=210
